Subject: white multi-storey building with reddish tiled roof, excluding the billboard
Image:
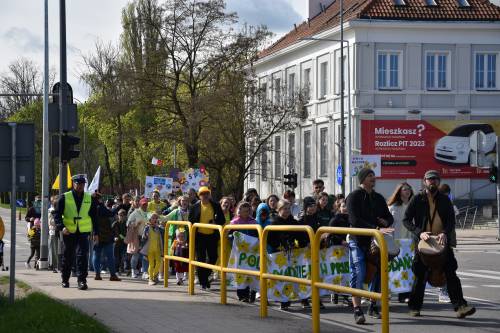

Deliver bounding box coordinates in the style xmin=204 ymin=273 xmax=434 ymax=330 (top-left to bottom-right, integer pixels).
xmin=245 ymin=0 xmax=500 ymax=200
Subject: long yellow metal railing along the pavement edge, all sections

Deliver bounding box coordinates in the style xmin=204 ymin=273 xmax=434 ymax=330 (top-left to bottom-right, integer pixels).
xmin=164 ymin=221 xmax=389 ymax=333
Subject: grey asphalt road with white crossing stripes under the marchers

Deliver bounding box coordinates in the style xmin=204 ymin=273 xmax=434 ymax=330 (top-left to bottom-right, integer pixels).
xmin=0 ymin=209 xmax=500 ymax=333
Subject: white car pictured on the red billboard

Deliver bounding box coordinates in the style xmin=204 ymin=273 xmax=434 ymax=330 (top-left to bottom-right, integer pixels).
xmin=434 ymin=124 xmax=496 ymax=167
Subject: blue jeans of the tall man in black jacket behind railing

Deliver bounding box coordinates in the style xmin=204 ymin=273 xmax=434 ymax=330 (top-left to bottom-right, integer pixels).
xmin=349 ymin=239 xmax=380 ymax=292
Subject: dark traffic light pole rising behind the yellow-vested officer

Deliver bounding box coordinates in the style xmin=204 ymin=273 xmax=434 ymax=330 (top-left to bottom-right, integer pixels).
xmin=59 ymin=0 xmax=68 ymax=194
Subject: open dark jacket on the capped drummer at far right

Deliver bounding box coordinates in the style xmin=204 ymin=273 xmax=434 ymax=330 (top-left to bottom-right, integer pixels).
xmin=403 ymin=191 xmax=455 ymax=244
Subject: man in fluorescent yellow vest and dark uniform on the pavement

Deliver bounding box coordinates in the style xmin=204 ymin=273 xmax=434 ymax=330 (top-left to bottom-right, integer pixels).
xmin=53 ymin=175 xmax=99 ymax=290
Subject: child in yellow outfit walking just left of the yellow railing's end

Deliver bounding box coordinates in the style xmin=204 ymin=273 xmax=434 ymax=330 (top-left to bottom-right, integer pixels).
xmin=141 ymin=212 xmax=163 ymax=286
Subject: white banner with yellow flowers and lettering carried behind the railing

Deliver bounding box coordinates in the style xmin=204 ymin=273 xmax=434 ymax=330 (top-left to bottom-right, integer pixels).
xmin=227 ymin=232 xmax=414 ymax=302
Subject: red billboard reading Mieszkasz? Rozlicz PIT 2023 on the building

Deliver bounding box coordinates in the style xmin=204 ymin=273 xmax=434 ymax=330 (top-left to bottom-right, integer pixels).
xmin=361 ymin=120 xmax=500 ymax=178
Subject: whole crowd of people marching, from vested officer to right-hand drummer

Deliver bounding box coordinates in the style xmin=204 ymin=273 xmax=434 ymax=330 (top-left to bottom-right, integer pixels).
xmin=21 ymin=168 xmax=475 ymax=324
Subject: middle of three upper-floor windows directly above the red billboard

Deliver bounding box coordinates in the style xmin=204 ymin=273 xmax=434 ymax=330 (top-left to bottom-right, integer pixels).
xmin=425 ymin=52 xmax=450 ymax=90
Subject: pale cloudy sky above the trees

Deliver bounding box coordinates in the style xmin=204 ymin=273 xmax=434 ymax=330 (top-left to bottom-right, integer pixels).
xmin=0 ymin=0 xmax=308 ymax=100
